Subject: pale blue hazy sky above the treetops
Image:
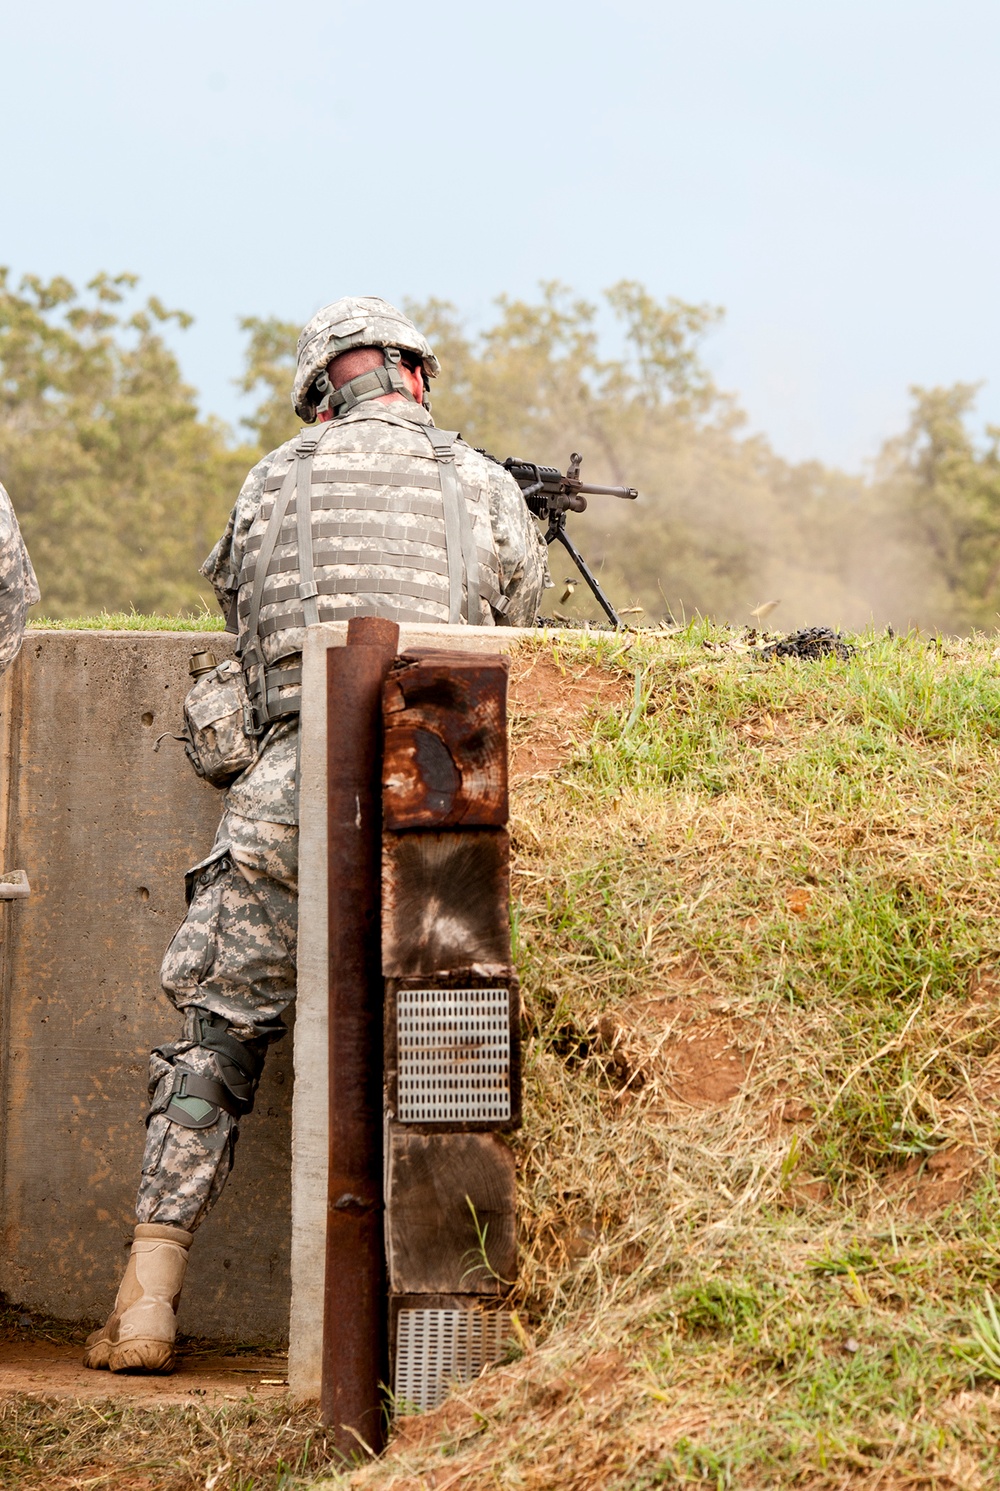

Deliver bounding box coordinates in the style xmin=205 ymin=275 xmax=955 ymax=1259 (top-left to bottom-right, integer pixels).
xmin=0 ymin=0 xmax=1000 ymax=467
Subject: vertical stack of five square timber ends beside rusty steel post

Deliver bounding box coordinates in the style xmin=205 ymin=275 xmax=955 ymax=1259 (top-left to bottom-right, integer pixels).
xmin=382 ymin=650 xmax=520 ymax=1408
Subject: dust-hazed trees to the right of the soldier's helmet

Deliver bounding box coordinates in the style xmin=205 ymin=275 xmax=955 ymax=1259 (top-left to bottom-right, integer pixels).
xmin=408 ymin=282 xmax=1000 ymax=629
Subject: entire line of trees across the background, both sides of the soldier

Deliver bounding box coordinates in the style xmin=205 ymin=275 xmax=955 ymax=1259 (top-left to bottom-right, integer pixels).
xmin=0 ymin=271 xmax=1000 ymax=629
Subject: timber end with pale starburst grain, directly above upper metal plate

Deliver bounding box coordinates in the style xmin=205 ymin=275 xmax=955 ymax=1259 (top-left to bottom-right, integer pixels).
xmin=382 ymin=829 xmax=510 ymax=978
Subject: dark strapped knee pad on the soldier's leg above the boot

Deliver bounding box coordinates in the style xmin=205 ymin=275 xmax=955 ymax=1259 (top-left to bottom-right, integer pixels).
xmin=146 ymin=1009 xmax=267 ymax=1129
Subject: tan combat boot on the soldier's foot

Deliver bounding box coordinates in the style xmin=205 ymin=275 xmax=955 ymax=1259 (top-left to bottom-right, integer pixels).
xmin=83 ymin=1223 xmax=192 ymax=1372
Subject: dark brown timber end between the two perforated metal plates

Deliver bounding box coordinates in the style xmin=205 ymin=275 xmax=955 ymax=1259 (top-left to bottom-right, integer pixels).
xmin=386 ymin=1126 xmax=517 ymax=1294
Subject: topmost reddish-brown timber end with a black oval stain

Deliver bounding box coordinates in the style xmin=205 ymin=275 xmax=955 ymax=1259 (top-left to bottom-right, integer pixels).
xmin=383 ymin=650 xmax=508 ymax=830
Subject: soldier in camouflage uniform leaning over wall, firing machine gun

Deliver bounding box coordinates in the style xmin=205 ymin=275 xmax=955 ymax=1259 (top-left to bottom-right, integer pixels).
xmin=83 ymin=297 xmax=551 ymax=1372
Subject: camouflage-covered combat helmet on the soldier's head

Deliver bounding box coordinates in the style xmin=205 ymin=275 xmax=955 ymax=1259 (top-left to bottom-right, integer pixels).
xmin=292 ymin=295 xmax=441 ymax=425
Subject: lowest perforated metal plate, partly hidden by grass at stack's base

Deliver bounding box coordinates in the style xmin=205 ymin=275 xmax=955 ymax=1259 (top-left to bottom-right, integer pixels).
xmin=393 ymin=1309 xmax=510 ymax=1413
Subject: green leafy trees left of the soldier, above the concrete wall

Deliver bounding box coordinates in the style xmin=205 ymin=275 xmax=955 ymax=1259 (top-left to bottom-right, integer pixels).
xmin=0 ymin=270 xmax=252 ymax=616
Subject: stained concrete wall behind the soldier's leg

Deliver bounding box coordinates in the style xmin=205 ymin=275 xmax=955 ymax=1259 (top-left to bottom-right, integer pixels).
xmin=0 ymin=632 xmax=292 ymax=1342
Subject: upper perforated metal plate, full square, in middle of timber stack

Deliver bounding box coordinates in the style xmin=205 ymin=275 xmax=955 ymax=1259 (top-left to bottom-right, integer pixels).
xmin=396 ymin=989 xmax=510 ymax=1123
